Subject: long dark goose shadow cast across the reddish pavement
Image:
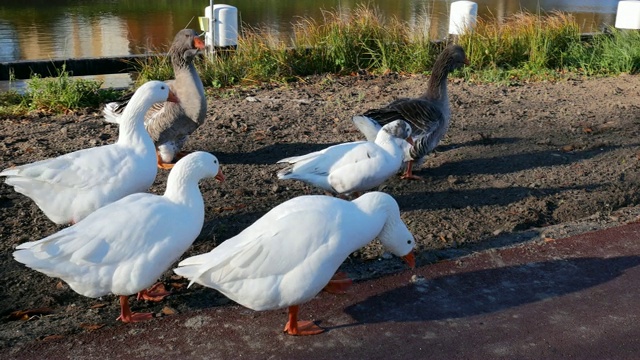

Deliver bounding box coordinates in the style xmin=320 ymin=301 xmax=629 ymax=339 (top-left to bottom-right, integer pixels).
xmin=345 ymin=256 xmax=640 ymax=326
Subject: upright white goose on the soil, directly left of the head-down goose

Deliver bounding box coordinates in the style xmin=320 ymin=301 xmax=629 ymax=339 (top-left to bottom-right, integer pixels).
xmin=13 ymin=152 xmax=224 ymax=322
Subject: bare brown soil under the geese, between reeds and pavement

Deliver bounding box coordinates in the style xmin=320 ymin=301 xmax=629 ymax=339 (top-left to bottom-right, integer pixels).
xmin=0 ymin=74 xmax=640 ymax=348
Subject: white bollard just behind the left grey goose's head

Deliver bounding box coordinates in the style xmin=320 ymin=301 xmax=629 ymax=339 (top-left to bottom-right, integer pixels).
xmin=203 ymin=4 xmax=238 ymax=50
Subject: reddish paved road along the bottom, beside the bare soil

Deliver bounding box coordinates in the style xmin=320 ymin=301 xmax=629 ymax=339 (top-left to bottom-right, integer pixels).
xmin=10 ymin=223 xmax=640 ymax=360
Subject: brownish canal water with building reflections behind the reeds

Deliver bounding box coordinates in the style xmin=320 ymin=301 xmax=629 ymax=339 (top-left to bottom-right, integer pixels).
xmin=0 ymin=0 xmax=618 ymax=85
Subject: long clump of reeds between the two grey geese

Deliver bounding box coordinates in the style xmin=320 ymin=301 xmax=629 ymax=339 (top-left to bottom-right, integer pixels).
xmin=138 ymin=6 xmax=437 ymax=87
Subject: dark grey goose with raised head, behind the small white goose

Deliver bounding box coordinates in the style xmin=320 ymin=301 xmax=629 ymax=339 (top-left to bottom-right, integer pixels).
xmin=353 ymin=45 xmax=469 ymax=180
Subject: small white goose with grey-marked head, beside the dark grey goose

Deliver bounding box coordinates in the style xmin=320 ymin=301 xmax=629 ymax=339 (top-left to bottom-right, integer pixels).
xmin=278 ymin=120 xmax=411 ymax=194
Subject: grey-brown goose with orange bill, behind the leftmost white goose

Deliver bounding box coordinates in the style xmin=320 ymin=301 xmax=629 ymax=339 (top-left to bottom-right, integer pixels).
xmin=104 ymin=29 xmax=207 ymax=169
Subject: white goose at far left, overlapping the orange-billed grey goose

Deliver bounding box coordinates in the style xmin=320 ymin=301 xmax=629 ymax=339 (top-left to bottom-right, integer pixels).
xmin=0 ymin=81 xmax=178 ymax=224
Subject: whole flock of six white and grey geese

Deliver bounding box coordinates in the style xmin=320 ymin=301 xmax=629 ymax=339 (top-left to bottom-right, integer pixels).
xmin=0 ymin=29 xmax=468 ymax=335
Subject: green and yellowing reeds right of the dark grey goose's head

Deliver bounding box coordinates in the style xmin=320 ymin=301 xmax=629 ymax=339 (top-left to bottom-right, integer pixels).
xmin=459 ymin=12 xmax=640 ymax=81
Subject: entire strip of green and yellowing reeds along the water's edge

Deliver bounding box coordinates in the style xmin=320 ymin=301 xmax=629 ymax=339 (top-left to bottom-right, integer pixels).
xmin=0 ymin=6 xmax=640 ymax=113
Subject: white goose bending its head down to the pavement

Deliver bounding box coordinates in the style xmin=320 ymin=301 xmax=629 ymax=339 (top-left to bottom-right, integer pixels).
xmin=173 ymin=192 xmax=415 ymax=335
